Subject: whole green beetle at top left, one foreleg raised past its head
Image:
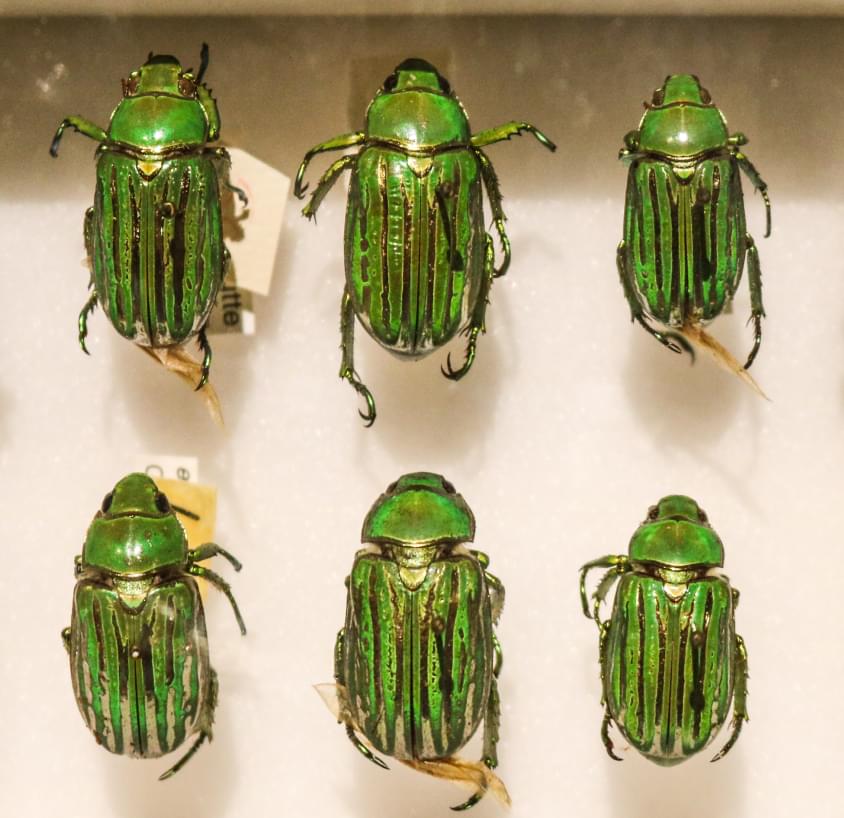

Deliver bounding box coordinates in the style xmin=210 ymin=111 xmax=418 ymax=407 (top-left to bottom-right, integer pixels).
xmin=50 ymin=44 xmax=245 ymax=389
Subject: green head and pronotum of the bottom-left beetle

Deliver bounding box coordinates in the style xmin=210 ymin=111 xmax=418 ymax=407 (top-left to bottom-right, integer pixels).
xmin=82 ymin=474 xmax=187 ymax=576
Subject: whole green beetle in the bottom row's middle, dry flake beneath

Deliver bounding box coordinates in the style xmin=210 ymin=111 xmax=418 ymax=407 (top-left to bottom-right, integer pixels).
xmin=335 ymin=472 xmax=507 ymax=809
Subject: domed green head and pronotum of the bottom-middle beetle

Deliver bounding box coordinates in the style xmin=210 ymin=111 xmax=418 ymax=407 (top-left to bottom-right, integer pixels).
xmin=361 ymin=472 xmax=475 ymax=548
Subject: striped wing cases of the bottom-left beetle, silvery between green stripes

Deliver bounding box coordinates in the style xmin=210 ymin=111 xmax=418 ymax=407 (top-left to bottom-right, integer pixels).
xmin=70 ymin=577 xmax=211 ymax=758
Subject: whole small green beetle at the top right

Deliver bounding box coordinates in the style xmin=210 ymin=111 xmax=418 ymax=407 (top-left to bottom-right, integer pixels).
xmin=617 ymin=74 xmax=771 ymax=369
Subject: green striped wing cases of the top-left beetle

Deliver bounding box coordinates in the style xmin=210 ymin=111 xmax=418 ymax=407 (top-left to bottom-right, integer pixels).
xmin=90 ymin=150 xmax=228 ymax=347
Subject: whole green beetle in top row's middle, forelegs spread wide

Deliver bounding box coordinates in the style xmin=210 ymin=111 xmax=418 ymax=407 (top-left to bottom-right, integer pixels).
xmin=294 ymin=59 xmax=556 ymax=425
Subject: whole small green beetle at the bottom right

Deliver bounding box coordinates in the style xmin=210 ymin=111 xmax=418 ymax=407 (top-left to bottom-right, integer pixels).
xmin=580 ymin=495 xmax=748 ymax=765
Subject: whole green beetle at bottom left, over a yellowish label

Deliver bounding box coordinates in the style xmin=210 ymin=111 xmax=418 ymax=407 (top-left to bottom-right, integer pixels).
xmin=62 ymin=474 xmax=246 ymax=779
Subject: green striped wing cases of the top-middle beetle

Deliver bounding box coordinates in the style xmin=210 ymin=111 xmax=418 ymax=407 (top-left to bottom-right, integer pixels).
xmin=345 ymin=146 xmax=486 ymax=356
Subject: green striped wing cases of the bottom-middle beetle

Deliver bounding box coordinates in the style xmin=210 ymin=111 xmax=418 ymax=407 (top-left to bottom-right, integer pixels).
xmin=343 ymin=552 xmax=495 ymax=759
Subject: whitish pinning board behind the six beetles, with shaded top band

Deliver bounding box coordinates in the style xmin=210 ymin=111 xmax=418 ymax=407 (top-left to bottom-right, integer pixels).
xmin=0 ymin=11 xmax=844 ymax=818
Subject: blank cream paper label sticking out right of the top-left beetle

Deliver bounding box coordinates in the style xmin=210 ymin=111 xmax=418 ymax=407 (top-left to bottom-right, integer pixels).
xmin=223 ymin=148 xmax=290 ymax=295
